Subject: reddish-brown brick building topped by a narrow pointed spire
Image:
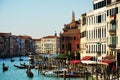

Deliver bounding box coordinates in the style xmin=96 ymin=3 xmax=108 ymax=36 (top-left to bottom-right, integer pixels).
xmin=60 ymin=12 xmax=80 ymax=53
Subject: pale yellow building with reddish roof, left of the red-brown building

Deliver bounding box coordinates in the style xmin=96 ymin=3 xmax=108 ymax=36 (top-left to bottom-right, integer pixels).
xmin=40 ymin=35 xmax=60 ymax=54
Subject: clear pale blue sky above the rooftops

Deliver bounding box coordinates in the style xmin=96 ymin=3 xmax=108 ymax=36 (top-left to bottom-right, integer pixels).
xmin=0 ymin=0 xmax=93 ymax=39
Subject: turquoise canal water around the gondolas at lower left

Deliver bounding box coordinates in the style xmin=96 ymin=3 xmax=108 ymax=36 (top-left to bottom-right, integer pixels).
xmin=0 ymin=57 xmax=84 ymax=80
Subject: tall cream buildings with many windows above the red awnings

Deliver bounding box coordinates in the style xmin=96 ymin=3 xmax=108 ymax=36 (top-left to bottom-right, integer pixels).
xmin=80 ymin=0 xmax=120 ymax=60
